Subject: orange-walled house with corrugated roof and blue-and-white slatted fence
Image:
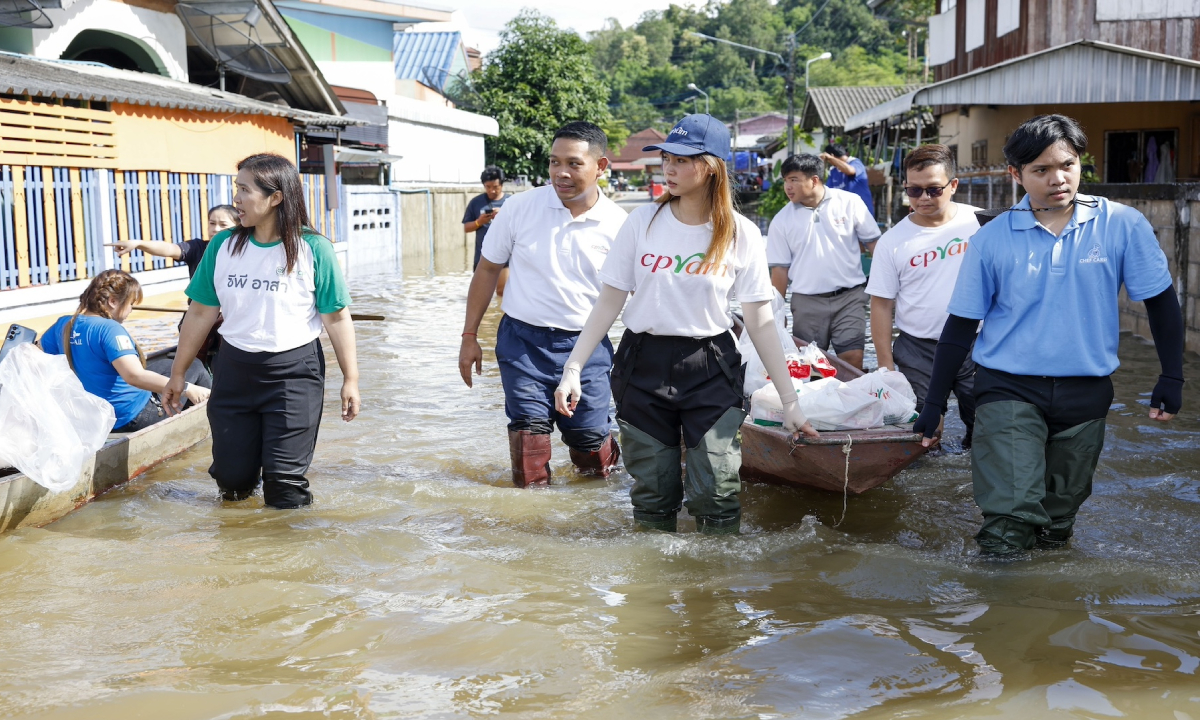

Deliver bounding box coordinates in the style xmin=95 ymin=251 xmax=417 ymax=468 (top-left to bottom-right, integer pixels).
xmin=0 ymin=0 xmax=360 ymax=320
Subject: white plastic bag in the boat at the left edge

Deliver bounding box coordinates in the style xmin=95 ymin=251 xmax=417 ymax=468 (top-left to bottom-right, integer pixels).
xmin=0 ymin=343 xmax=116 ymax=492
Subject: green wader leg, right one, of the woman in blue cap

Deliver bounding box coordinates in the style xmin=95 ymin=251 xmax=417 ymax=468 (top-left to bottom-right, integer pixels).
xmin=684 ymin=408 xmax=746 ymax=535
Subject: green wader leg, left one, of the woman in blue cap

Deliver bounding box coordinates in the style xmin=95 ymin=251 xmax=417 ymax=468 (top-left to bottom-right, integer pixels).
xmin=617 ymin=420 xmax=683 ymax=533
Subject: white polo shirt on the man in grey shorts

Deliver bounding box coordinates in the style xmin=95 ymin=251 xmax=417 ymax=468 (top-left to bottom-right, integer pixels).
xmin=767 ymin=187 xmax=880 ymax=295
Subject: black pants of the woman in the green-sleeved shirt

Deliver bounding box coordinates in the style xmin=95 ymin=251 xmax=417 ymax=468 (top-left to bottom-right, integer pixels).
xmin=209 ymin=340 xmax=325 ymax=508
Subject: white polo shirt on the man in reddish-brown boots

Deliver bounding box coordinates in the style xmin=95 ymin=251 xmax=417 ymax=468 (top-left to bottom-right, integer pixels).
xmin=482 ymin=185 xmax=629 ymax=332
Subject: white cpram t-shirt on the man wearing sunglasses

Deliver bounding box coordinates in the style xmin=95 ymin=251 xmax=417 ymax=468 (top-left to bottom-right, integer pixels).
xmin=866 ymin=203 xmax=979 ymax=340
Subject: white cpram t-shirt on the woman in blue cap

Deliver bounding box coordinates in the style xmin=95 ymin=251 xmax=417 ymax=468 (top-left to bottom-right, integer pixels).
xmin=600 ymin=203 xmax=775 ymax=337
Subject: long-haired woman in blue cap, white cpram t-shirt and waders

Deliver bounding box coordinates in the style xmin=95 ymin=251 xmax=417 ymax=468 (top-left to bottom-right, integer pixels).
xmin=554 ymin=115 xmax=816 ymax=534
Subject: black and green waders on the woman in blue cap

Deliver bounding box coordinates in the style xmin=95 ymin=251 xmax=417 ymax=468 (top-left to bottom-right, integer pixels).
xmin=613 ymin=330 xmax=745 ymax=534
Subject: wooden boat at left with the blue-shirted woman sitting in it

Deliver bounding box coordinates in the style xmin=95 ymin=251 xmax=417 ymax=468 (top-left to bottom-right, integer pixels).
xmin=0 ymin=348 xmax=209 ymax=533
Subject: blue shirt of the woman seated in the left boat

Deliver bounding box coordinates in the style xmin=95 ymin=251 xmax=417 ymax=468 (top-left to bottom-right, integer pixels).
xmin=42 ymin=314 xmax=150 ymax=427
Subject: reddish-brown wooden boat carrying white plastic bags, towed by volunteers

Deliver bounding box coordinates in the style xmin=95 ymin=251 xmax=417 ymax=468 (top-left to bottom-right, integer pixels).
xmin=734 ymin=322 xmax=925 ymax=494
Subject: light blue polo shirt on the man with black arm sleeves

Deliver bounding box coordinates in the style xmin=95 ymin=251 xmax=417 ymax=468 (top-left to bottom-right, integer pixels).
xmin=948 ymin=194 xmax=1171 ymax=377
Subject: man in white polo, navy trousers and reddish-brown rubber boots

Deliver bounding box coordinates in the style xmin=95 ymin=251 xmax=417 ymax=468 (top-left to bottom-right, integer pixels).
xmin=458 ymin=122 xmax=628 ymax=487
